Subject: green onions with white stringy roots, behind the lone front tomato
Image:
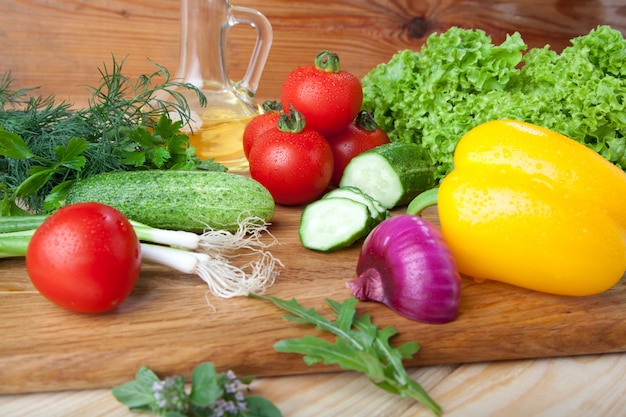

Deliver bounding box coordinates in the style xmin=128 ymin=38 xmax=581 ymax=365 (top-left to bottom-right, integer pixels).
xmin=0 ymin=215 xmax=283 ymax=298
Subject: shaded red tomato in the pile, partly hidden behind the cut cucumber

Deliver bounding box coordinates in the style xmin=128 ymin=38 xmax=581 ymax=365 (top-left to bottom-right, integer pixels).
xmin=326 ymin=111 xmax=389 ymax=185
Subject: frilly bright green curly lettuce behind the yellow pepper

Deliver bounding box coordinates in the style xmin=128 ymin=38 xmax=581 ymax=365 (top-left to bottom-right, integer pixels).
xmin=363 ymin=26 xmax=626 ymax=179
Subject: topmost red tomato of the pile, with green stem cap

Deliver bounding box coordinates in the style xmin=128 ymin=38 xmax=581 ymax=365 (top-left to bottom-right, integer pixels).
xmin=280 ymin=51 xmax=363 ymax=136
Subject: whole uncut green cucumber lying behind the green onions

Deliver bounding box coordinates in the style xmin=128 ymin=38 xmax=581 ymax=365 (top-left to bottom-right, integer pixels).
xmin=66 ymin=170 xmax=275 ymax=232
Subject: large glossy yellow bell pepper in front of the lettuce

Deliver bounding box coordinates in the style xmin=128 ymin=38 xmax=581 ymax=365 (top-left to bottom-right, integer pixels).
xmin=437 ymin=120 xmax=626 ymax=296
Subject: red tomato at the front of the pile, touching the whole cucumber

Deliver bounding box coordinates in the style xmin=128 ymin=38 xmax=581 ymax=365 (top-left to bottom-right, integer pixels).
xmin=249 ymin=128 xmax=333 ymax=205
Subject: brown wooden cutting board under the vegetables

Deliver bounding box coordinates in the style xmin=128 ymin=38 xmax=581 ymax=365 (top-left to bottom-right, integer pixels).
xmin=0 ymin=207 xmax=626 ymax=393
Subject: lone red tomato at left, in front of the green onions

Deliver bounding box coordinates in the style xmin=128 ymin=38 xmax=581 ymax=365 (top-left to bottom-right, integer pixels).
xmin=26 ymin=203 xmax=141 ymax=313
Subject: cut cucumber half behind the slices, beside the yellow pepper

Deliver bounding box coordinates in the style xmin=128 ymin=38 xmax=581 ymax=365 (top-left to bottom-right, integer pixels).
xmin=339 ymin=142 xmax=435 ymax=209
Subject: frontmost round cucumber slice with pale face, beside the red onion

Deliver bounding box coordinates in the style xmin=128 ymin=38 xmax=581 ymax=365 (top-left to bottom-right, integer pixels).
xmin=298 ymin=197 xmax=374 ymax=252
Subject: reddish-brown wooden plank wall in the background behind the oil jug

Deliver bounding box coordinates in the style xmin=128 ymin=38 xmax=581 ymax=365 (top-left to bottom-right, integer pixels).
xmin=0 ymin=0 xmax=626 ymax=106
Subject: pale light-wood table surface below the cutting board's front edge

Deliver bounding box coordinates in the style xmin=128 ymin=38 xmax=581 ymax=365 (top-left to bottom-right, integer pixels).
xmin=0 ymin=354 xmax=626 ymax=417
